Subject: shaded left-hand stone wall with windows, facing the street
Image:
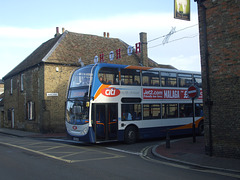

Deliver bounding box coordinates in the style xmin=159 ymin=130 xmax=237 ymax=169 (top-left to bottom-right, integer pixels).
xmin=4 ymin=66 xmax=42 ymax=132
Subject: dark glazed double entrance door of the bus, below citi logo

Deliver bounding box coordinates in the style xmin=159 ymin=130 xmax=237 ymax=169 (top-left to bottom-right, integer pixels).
xmin=94 ymin=103 xmax=118 ymax=141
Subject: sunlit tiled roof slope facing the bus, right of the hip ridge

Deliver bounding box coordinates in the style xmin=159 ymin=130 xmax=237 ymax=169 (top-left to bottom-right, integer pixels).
xmin=46 ymin=32 xmax=142 ymax=65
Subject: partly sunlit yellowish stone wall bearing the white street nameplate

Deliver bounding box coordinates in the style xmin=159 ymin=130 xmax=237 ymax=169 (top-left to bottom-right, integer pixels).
xmin=42 ymin=64 xmax=76 ymax=132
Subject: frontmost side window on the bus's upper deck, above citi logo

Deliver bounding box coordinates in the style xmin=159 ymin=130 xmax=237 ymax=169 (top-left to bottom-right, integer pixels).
xmin=98 ymin=67 xmax=119 ymax=85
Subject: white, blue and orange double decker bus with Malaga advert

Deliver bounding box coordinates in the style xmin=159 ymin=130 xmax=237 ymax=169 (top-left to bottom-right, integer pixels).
xmin=65 ymin=63 xmax=204 ymax=143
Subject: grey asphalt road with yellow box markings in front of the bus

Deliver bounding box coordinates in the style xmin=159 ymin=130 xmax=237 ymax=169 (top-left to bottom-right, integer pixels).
xmin=0 ymin=134 xmax=234 ymax=180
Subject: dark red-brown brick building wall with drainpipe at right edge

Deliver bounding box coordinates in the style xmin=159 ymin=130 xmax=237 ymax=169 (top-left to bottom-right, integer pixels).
xmin=196 ymin=0 xmax=240 ymax=158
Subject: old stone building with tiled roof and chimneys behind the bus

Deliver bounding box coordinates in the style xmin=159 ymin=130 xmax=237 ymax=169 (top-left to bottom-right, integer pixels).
xmin=3 ymin=28 xmax=173 ymax=133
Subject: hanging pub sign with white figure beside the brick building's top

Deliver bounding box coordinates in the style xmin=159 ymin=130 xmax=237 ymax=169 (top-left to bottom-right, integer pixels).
xmin=174 ymin=0 xmax=190 ymax=21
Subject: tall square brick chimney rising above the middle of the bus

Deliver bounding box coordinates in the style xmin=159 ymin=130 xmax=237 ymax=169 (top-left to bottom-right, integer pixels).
xmin=140 ymin=32 xmax=148 ymax=67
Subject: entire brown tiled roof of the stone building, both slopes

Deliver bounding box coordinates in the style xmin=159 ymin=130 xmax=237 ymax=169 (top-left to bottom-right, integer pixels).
xmin=3 ymin=31 xmax=174 ymax=79
